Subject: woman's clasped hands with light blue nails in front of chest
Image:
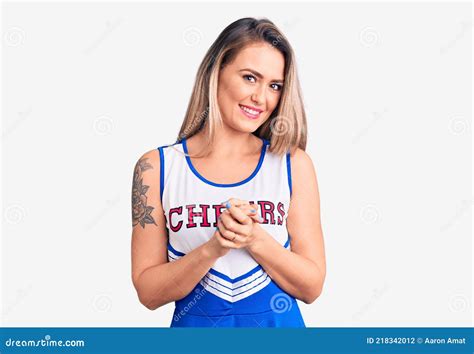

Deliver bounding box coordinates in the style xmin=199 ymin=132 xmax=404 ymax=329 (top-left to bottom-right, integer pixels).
xmin=217 ymin=198 xmax=262 ymax=248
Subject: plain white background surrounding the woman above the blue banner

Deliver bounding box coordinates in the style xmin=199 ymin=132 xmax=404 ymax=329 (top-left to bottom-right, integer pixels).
xmin=1 ymin=2 xmax=474 ymax=327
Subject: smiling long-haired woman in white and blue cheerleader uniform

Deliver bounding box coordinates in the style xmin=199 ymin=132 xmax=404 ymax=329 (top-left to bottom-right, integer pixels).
xmin=132 ymin=18 xmax=326 ymax=327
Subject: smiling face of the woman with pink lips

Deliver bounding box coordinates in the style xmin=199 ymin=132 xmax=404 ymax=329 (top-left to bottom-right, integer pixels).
xmin=217 ymin=43 xmax=285 ymax=132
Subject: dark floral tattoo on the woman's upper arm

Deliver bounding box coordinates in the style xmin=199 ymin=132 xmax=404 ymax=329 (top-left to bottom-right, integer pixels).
xmin=132 ymin=158 xmax=156 ymax=228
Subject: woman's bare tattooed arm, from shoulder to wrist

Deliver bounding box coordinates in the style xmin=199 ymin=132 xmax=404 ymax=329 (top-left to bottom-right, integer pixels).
xmin=131 ymin=150 xmax=227 ymax=310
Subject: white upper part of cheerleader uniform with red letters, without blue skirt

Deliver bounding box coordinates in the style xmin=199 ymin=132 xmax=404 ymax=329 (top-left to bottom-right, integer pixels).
xmin=158 ymin=139 xmax=291 ymax=302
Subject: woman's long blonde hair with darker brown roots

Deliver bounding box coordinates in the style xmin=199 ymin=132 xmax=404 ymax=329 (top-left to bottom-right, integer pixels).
xmin=177 ymin=17 xmax=307 ymax=156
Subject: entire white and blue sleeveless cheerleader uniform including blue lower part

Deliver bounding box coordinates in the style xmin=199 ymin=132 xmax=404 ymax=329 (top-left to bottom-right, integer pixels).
xmin=157 ymin=139 xmax=306 ymax=327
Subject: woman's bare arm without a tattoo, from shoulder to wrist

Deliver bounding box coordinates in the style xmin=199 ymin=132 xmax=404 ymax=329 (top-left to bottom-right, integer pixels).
xmin=244 ymin=149 xmax=326 ymax=304
